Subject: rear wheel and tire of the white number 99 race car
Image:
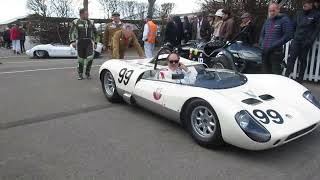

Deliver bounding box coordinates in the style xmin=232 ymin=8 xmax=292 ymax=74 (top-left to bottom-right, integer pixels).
xmin=101 ymin=70 xmax=122 ymax=103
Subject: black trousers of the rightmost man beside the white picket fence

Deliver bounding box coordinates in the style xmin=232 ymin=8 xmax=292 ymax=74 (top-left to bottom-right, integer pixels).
xmin=285 ymin=40 xmax=311 ymax=81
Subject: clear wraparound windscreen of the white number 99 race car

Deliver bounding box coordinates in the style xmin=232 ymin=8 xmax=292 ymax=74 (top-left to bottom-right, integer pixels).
xmin=185 ymin=66 xmax=247 ymax=89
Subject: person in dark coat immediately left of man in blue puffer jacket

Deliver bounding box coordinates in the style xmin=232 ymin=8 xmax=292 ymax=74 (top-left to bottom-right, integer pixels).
xmin=238 ymin=13 xmax=256 ymax=45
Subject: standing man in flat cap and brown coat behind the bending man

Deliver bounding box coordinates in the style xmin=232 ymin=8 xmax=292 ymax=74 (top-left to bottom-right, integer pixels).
xmin=104 ymin=12 xmax=123 ymax=55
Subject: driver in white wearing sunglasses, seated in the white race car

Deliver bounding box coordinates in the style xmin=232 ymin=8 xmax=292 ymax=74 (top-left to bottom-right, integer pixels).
xmin=159 ymin=53 xmax=191 ymax=82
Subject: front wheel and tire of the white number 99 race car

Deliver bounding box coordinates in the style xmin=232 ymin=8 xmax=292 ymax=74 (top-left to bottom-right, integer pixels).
xmin=184 ymin=99 xmax=223 ymax=148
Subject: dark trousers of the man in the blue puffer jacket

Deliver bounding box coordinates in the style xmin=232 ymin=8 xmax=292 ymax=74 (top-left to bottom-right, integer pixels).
xmin=262 ymin=48 xmax=284 ymax=75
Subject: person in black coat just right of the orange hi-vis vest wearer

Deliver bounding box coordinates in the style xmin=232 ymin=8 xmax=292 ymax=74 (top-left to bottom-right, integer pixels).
xmin=164 ymin=17 xmax=179 ymax=46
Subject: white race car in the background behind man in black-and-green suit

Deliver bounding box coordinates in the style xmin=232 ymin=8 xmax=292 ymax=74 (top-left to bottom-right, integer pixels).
xmin=26 ymin=43 xmax=103 ymax=58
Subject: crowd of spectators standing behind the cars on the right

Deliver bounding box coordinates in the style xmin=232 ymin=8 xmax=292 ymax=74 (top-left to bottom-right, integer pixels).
xmin=160 ymin=0 xmax=320 ymax=82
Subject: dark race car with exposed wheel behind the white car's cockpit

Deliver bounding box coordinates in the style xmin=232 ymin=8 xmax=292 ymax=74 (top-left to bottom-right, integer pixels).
xmin=179 ymin=29 xmax=262 ymax=73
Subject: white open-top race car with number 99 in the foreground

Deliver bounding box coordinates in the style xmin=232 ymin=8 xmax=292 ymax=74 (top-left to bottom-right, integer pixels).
xmin=99 ymin=46 xmax=320 ymax=150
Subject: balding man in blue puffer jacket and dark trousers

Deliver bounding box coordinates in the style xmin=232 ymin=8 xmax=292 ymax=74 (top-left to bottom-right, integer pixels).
xmin=259 ymin=3 xmax=293 ymax=74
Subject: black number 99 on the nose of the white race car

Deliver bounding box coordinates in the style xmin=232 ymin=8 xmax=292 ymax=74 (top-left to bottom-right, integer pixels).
xmin=253 ymin=109 xmax=284 ymax=124
